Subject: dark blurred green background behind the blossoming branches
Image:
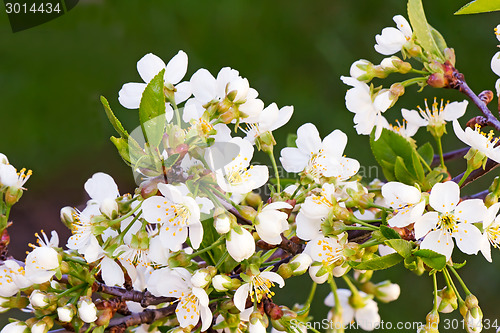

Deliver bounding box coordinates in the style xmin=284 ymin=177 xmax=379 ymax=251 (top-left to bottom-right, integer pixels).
xmin=0 ymin=0 xmax=500 ymax=331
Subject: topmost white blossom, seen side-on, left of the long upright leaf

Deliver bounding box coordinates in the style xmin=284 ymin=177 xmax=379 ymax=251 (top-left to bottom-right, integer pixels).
xmin=375 ymin=15 xmax=413 ymax=55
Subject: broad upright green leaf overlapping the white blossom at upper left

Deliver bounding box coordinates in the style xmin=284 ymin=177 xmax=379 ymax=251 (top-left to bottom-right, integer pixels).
xmin=139 ymin=69 xmax=167 ymax=148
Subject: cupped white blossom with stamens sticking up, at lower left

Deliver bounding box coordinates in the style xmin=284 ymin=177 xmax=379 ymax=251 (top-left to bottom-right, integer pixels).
xmin=25 ymin=231 xmax=60 ymax=284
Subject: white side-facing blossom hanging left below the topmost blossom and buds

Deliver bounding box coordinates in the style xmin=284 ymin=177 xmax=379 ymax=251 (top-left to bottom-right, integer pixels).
xmin=340 ymin=76 xmax=392 ymax=140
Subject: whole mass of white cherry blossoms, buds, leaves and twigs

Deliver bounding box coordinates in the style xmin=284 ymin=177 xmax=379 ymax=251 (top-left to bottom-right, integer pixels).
xmin=0 ymin=0 xmax=500 ymax=333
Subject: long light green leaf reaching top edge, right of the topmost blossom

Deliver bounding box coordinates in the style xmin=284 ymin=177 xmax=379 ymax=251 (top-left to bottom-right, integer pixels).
xmin=408 ymin=0 xmax=444 ymax=59
